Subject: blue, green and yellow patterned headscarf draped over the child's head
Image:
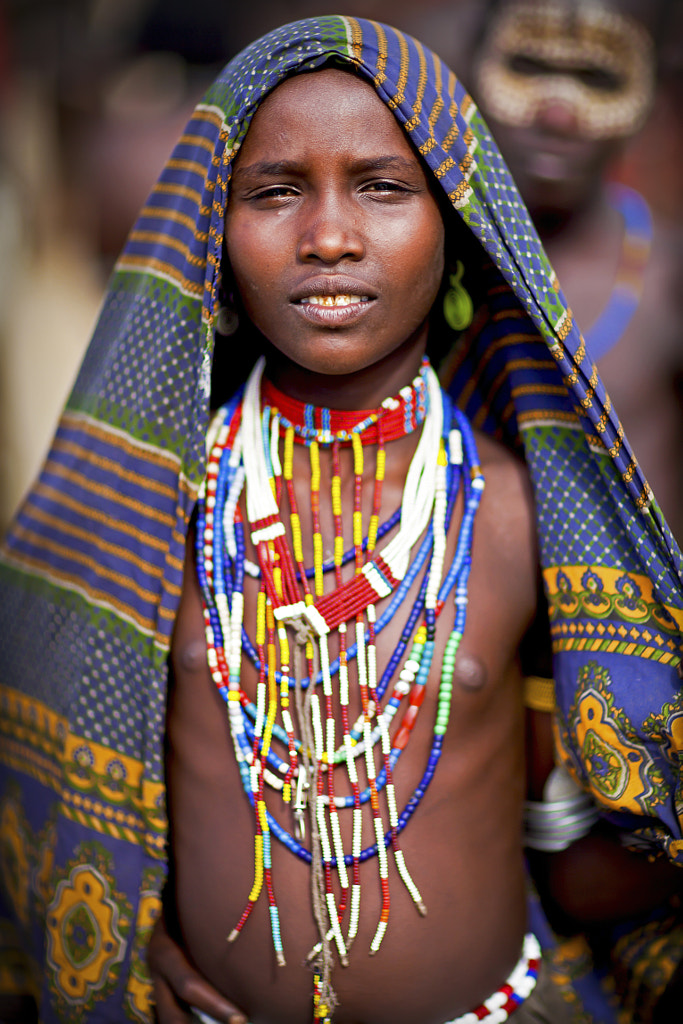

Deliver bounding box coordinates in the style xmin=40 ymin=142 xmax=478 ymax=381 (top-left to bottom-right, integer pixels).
xmin=0 ymin=16 xmax=683 ymax=1024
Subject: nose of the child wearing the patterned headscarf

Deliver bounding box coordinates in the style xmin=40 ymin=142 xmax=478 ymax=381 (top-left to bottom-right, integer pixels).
xmin=298 ymin=195 xmax=366 ymax=263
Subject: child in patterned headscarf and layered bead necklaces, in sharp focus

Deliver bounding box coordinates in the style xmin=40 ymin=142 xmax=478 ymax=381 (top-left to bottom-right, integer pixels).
xmin=3 ymin=17 xmax=683 ymax=1024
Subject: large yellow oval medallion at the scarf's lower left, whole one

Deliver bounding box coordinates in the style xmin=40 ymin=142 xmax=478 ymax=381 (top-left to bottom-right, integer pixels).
xmin=46 ymin=843 xmax=132 ymax=1024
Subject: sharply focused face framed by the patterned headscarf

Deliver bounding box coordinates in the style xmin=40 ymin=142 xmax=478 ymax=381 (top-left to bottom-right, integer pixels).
xmin=225 ymin=70 xmax=444 ymax=395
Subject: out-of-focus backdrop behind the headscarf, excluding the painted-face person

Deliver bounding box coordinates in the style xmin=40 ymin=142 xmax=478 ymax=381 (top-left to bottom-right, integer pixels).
xmin=0 ymin=0 xmax=683 ymax=526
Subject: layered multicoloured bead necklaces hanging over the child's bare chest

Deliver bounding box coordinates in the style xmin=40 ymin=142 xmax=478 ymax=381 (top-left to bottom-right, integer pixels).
xmin=197 ymin=360 xmax=483 ymax=1022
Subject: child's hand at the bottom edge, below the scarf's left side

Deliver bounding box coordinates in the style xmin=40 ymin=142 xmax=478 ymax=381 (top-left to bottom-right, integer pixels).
xmin=147 ymin=914 xmax=248 ymax=1024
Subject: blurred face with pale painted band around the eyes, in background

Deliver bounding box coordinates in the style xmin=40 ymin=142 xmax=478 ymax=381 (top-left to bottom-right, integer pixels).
xmin=475 ymin=0 xmax=654 ymax=212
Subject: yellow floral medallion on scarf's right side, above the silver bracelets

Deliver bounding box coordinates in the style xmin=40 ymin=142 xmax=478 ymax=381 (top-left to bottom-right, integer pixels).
xmin=555 ymin=660 xmax=664 ymax=815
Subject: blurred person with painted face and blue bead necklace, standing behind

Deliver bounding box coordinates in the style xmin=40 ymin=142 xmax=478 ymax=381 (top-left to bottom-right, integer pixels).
xmin=470 ymin=0 xmax=683 ymax=541
